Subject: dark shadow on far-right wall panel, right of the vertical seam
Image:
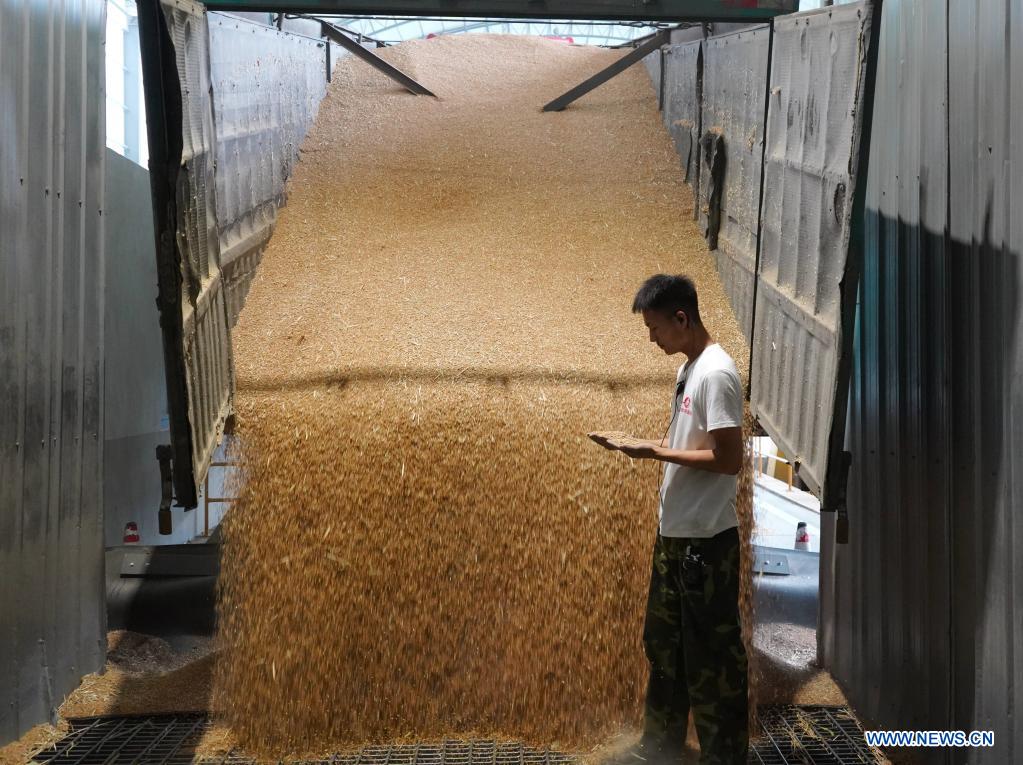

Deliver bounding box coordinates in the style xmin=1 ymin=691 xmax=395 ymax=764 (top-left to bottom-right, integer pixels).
xmin=946 ymin=194 xmax=1023 ymax=754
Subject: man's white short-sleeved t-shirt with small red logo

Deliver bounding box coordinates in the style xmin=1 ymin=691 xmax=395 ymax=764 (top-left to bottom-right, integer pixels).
xmin=661 ymin=343 xmax=743 ymax=538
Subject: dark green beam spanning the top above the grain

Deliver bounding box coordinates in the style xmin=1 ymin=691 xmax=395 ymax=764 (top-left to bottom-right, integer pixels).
xmin=206 ymin=0 xmax=799 ymax=21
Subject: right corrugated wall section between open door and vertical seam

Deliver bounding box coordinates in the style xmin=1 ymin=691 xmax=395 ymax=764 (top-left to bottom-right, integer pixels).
xmin=819 ymin=0 xmax=951 ymax=729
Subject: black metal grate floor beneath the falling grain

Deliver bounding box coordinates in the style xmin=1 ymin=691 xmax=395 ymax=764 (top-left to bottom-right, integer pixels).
xmin=28 ymin=707 xmax=880 ymax=765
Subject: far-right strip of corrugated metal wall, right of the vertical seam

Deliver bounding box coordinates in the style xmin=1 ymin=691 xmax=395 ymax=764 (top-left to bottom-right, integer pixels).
xmin=945 ymin=0 xmax=1023 ymax=765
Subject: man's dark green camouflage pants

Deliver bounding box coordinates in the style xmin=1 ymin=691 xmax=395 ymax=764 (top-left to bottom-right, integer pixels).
xmin=643 ymin=528 xmax=749 ymax=765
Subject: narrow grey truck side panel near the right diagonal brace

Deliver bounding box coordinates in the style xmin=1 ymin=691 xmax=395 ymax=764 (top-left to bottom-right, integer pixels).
xmin=664 ymin=41 xmax=703 ymax=198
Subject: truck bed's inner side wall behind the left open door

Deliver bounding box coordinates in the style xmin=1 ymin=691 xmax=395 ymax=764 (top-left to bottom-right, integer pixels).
xmin=207 ymin=13 xmax=329 ymax=324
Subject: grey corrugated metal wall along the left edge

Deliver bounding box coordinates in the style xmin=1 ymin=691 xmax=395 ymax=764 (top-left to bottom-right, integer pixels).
xmin=0 ymin=0 xmax=105 ymax=744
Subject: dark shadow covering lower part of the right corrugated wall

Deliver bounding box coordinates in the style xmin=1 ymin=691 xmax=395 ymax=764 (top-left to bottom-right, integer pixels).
xmin=842 ymin=192 xmax=1023 ymax=762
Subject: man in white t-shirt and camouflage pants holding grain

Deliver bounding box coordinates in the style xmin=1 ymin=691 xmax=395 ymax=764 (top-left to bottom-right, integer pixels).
xmin=590 ymin=274 xmax=749 ymax=765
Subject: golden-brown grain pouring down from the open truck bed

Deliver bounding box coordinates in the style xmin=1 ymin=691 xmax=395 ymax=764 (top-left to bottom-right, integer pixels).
xmin=216 ymin=36 xmax=747 ymax=753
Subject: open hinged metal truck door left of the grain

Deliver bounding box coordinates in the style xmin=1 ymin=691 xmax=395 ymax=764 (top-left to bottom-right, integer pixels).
xmin=138 ymin=0 xmax=234 ymax=507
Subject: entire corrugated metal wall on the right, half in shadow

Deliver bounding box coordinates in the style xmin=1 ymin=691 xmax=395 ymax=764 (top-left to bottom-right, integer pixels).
xmin=820 ymin=0 xmax=1023 ymax=765
